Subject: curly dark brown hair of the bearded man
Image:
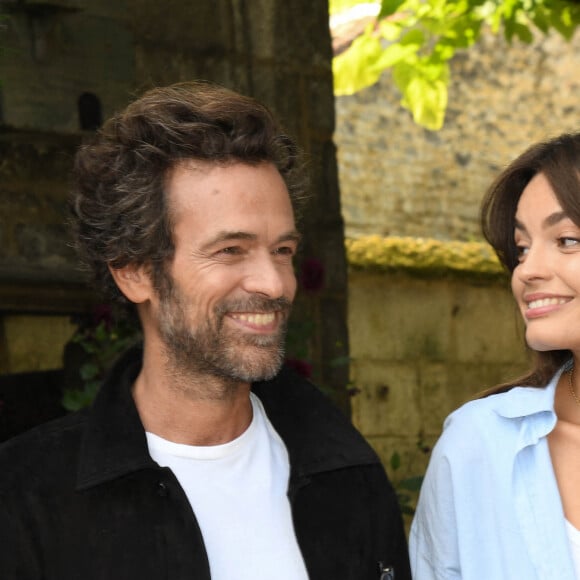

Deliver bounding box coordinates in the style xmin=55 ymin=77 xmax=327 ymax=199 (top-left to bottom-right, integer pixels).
xmin=71 ymin=82 xmax=306 ymax=302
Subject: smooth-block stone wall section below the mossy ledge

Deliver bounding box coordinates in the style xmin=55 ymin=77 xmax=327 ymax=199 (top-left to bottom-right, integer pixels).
xmin=348 ymin=271 xmax=528 ymax=481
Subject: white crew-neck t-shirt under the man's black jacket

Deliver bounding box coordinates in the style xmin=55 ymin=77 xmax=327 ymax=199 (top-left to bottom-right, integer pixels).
xmin=147 ymin=394 xmax=308 ymax=580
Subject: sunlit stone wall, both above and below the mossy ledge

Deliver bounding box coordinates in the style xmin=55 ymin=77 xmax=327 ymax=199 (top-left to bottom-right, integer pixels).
xmin=335 ymin=26 xmax=580 ymax=480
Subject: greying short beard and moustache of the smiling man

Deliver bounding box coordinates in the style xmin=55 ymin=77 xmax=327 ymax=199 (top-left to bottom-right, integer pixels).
xmin=158 ymin=277 xmax=291 ymax=383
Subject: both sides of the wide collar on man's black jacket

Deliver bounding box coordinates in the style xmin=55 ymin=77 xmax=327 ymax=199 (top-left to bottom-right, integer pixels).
xmin=77 ymin=347 xmax=379 ymax=489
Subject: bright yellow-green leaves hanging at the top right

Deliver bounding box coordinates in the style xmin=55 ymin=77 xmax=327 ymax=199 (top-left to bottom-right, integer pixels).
xmin=330 ymin=0 xmax=580 ymax=131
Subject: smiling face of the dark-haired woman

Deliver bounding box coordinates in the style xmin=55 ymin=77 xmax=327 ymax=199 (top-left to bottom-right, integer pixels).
xmin=512 ymin=173 xmax=580 ymax=353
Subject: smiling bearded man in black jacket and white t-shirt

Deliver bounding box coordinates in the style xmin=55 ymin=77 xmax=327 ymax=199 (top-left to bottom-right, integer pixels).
xmin=0 ymin=83 xmax=410 ymax=580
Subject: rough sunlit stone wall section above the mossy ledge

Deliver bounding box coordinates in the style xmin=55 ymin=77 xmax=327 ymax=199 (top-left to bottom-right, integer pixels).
xmin=335 ymin=26 xmax=580 ymax=240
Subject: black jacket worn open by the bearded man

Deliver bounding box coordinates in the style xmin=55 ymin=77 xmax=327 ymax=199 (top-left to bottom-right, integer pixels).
xmin=0 ymin=352 xmax=410 ymax=580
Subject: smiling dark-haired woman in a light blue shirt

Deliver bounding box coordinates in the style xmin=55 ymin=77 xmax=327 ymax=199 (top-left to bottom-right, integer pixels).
xmin=410 ymin=133 xmax=580 ymax=580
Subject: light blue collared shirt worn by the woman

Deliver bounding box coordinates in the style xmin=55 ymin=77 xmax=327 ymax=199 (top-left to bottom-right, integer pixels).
xmin=409 ymin=369 xmax=580 ymax=580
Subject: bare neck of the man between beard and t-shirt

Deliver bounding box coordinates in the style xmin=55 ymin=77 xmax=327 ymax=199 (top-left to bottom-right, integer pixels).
xmin=133 ymin=352 xmax=252 ymax=445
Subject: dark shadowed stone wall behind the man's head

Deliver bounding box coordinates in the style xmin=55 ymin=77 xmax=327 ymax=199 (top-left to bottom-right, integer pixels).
xmin=0 ymin=0 xmax=348 ymax=416
